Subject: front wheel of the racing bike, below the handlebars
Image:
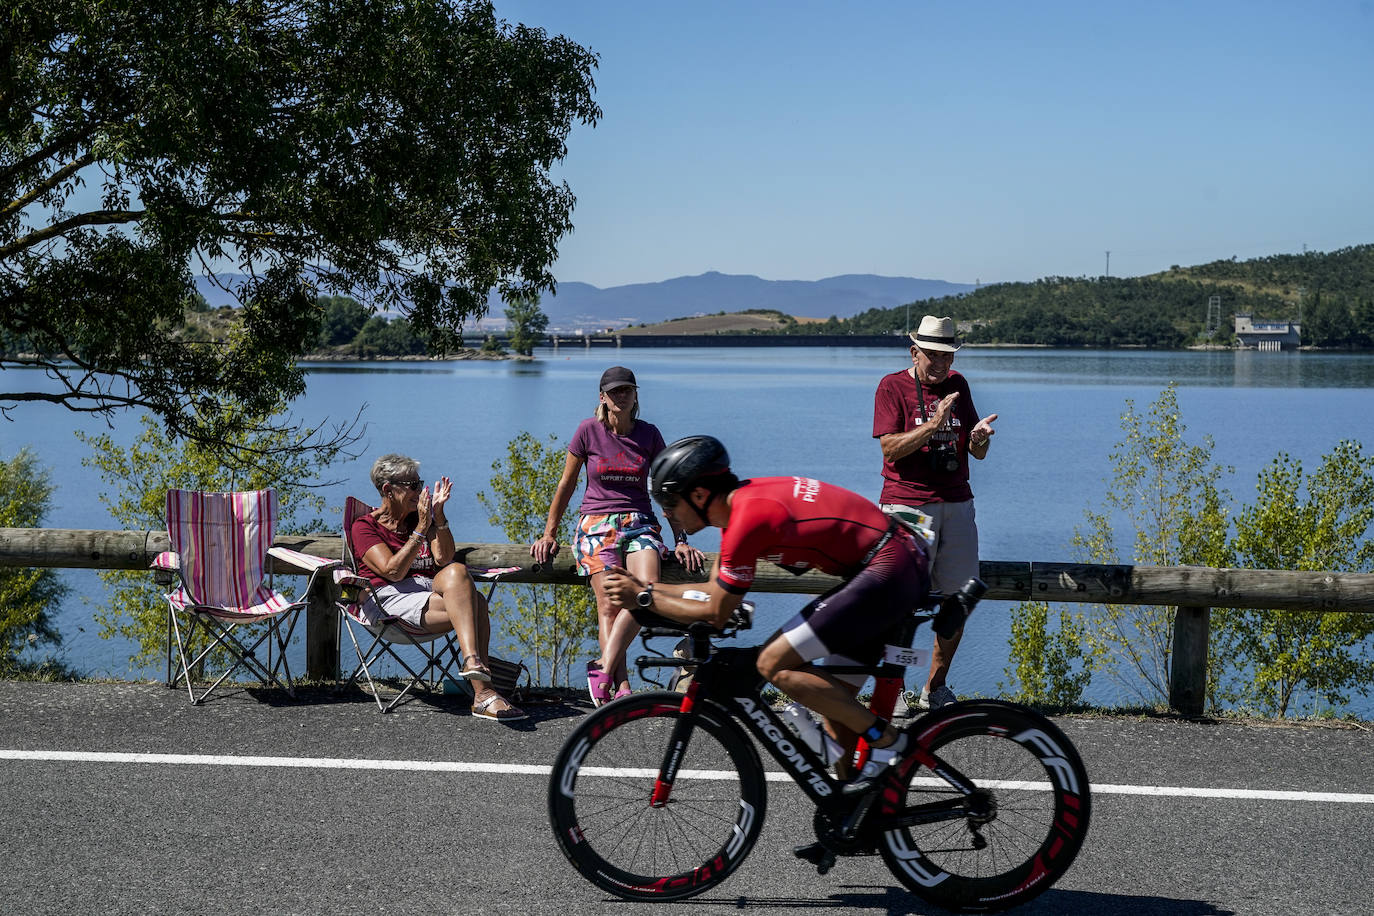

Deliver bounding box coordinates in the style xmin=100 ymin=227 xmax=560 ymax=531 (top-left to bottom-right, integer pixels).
xmin=548 ymin=692 xmax=765 ymax=901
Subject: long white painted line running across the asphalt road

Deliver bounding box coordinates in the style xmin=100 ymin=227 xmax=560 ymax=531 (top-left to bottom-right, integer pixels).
xmin=0 ymin=748 xmax=1374 ymax=805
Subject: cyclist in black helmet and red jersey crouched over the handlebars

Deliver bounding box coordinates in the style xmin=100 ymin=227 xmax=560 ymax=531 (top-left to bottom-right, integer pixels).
xmin=605 ymin=435 xmax=930 ymax=788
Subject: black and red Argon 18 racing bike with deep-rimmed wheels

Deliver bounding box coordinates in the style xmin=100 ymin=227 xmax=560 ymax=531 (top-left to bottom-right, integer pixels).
xmin=548 ymin=582 xmax=1091 ymax=912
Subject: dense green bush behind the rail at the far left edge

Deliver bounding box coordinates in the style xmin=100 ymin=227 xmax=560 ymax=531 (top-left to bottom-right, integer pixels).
xmin=0 ymin=449 xmax=69 ymax=676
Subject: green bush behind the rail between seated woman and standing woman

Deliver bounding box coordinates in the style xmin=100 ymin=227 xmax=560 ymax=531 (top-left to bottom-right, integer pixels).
xmin=477 ymin=433 xmax=596 ymax=684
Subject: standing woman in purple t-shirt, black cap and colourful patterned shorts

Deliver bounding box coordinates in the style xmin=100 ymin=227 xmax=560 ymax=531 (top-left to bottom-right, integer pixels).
xmin=529 ymin=365 xmax=702 ymax=706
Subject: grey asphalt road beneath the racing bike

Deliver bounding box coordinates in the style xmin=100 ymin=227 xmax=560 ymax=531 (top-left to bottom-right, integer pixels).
xmin=0 ymin=683 xmax=1374 ymax=916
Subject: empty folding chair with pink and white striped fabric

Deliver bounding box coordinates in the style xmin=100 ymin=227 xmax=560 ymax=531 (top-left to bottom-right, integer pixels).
xmin=153 ymin=490 xmax=327 ymax=705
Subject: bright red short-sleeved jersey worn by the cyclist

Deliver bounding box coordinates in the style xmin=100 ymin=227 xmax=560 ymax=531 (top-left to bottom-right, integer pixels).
xmin=716 ymin=477 xmax=889 ymax=595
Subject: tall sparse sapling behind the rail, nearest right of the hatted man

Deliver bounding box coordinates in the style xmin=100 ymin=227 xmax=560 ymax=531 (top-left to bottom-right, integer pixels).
xmin=1073 ymin=385 xmax=1230 ymax=702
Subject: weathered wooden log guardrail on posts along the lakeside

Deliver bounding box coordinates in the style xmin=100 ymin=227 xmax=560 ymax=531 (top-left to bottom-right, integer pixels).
xmin=0 ymin=527 xmax=1374 ymax=715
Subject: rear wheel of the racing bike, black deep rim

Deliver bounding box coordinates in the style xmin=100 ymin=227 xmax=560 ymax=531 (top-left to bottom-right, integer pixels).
xmin=879 ymin=700 xmax=1091 ymax=912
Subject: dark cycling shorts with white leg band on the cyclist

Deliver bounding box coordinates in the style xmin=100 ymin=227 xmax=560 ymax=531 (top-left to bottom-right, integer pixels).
xmin=782 ymin=529 xmax=930 ymax=665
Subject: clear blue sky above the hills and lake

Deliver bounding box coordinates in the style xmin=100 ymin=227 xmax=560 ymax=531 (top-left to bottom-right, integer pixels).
xmin=496 ymin=0 xmax=1374 ymax=287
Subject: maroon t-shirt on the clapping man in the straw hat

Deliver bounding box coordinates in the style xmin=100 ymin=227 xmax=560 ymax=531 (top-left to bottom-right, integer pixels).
xmin=872 ymin=369 xmax=978 ymax=505
